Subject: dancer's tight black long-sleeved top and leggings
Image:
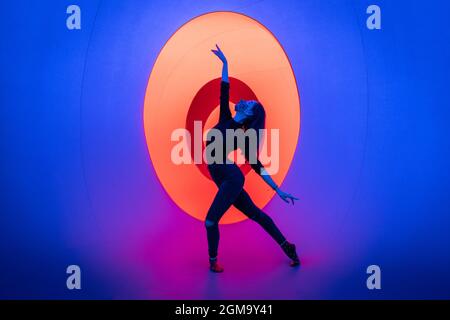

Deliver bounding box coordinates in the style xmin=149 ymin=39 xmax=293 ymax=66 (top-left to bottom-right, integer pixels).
xmin=205 ymin=81 xmax=286 ymax=258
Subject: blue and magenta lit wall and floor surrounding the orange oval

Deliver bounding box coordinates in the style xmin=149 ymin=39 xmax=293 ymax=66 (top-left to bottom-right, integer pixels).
xmin=0 ymin=0 xmax=450 ymax=299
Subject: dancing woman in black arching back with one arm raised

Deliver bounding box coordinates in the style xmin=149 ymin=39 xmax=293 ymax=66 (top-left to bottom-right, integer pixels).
xmin=205 ymin=45 xmax=300 ymax=272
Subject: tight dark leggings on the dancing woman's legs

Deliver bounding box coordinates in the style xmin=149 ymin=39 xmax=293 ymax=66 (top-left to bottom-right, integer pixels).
xmin=205 ymin=163 xmax=286 ymax=258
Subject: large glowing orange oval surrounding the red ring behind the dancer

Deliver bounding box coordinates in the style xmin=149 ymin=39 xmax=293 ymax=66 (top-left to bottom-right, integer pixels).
xmin=144 ymin=12 xmax=300 ymax=223
